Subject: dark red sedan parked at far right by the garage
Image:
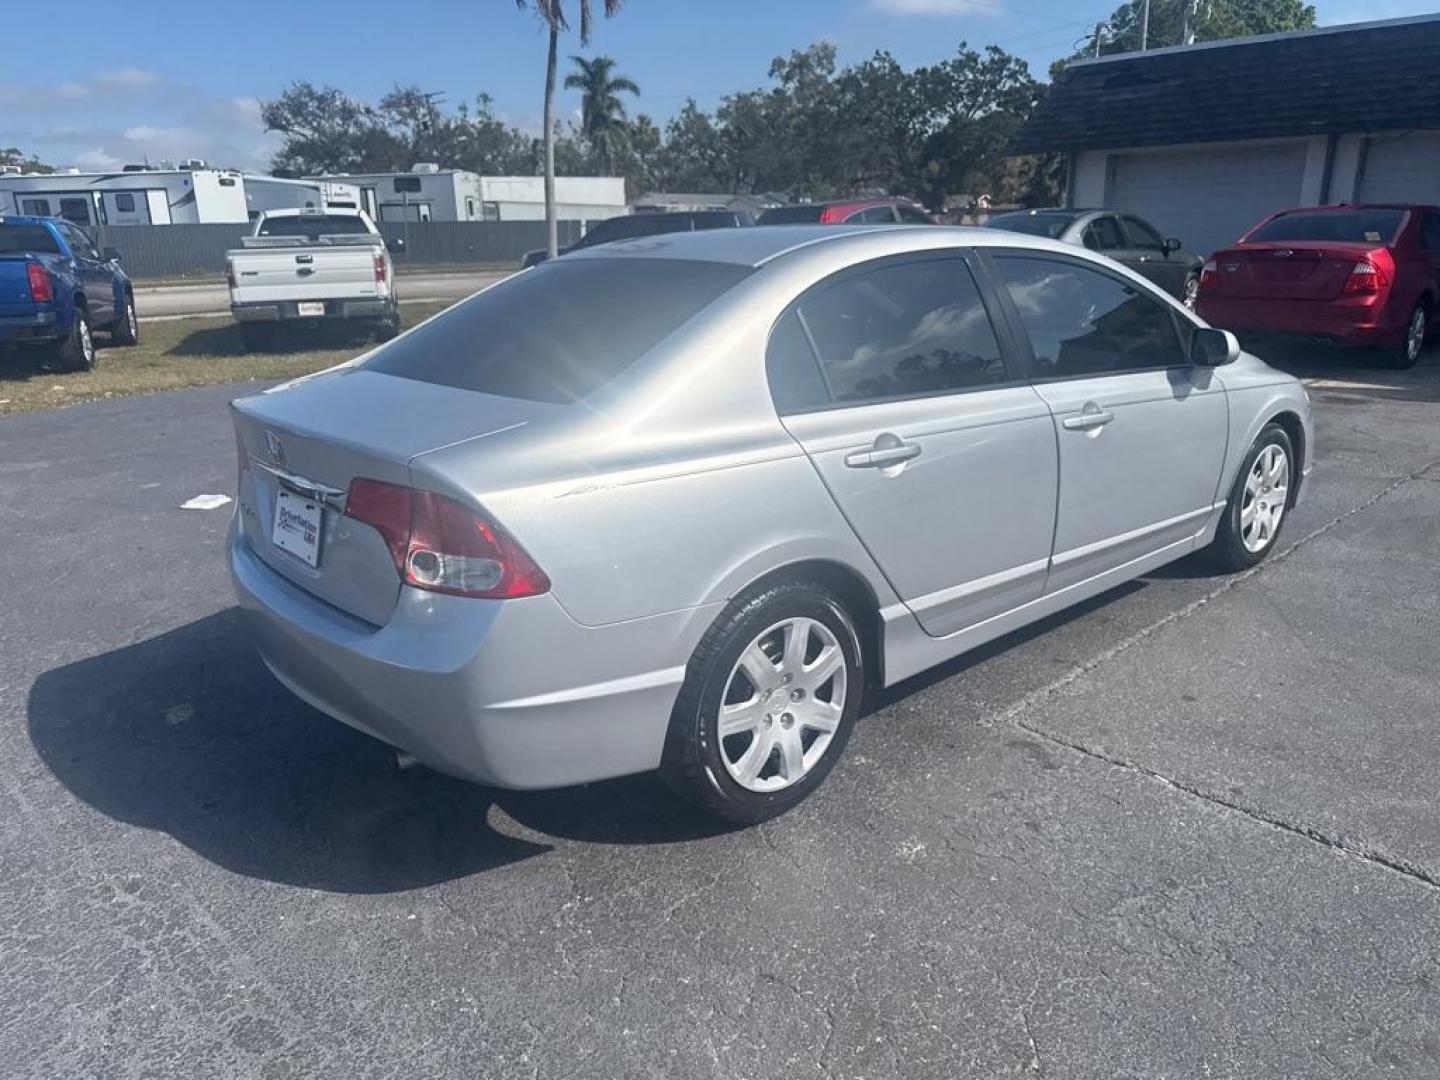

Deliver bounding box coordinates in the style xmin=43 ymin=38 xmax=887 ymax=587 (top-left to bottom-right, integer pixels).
xmin=1197 ymin=206 xmax=1440 ymax=369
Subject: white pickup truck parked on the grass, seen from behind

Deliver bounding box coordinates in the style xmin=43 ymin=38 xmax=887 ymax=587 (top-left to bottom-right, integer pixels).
xmin=225 ymin=209 xmax=400 ymax=348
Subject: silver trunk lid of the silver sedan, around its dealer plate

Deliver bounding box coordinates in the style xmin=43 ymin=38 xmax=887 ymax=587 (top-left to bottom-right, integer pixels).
xmin=232 ymin=369 xmax=563 ymax=626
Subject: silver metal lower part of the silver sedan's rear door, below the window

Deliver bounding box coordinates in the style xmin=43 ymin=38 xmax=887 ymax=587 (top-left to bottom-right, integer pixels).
xmin=785 ymin=386 xmax=1057 ymax=636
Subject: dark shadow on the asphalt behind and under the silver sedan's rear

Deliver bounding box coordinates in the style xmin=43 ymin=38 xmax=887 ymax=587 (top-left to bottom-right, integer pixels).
xmin=29 ymin=609 xmax=724 ymax=893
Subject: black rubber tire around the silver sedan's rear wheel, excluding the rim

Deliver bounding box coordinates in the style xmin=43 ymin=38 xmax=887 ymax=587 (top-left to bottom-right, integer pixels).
xmin=660 ymin=579 xmax=865 ymax=825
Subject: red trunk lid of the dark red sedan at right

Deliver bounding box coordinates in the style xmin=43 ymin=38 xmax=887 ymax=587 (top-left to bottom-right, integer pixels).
xmin=1215 ymin=240 xmax=1384 ymax=300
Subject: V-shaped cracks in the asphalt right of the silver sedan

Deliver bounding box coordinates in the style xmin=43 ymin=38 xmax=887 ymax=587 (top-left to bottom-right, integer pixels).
xmin=982 ymin=461 xmax=1440 ymax=888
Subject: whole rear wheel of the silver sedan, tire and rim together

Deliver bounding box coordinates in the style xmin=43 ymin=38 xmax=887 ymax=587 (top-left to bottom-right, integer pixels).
xmin=661 ymin=580 xmax=864 ymax=825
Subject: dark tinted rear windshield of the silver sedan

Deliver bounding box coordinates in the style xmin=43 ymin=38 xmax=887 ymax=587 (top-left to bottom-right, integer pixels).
xmin=361 ymin=258 xmax=750 ymax=405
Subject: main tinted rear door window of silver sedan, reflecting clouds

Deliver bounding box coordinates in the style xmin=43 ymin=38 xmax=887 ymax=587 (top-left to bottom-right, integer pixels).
xmin=799 ymin=259 xmax=1008 ymax=403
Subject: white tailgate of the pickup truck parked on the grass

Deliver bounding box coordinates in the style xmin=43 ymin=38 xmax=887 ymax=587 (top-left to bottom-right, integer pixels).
xmin=229 ymin=243 xmax=383 ymax=304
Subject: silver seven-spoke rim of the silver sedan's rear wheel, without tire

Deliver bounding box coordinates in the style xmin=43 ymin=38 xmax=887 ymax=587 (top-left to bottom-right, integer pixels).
xmin=717 ymin=616 xmax=850 ymax=792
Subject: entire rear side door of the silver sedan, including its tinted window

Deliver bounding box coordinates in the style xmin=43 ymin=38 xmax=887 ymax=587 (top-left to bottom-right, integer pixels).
xmin=766 ymin=252 xmax=1057 ymax=635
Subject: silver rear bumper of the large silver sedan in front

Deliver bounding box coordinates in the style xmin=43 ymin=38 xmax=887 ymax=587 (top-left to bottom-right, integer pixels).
xmin=229 ymin=527 xmax=706 ymax=788
